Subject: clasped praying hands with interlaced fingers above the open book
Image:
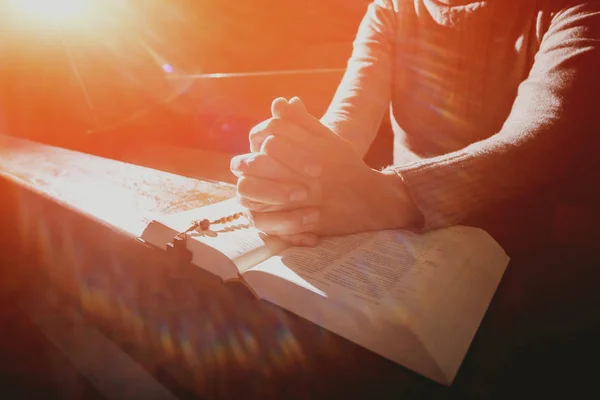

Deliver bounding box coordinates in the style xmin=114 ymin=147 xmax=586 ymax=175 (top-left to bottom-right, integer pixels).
xmin=231 ymin=98 xmax=413 ymax=246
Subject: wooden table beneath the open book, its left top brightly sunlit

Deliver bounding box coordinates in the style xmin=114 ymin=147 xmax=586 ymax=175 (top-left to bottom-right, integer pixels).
xmin=0 ymin=137 xmax=600 ymax=399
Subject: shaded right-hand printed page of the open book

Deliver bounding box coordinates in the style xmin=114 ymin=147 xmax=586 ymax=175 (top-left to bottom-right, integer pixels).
xmin=247 ymin=226 xmax=508 ymax=381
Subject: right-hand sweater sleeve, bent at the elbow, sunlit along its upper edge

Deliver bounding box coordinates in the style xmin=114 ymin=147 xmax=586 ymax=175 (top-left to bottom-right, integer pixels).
xmin=392 ymin=2 xmax=600 ymax=230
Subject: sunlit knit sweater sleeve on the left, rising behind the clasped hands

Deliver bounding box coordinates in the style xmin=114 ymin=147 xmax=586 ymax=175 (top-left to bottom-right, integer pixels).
xmin=321 ymin=0 xmax=396 ymax=156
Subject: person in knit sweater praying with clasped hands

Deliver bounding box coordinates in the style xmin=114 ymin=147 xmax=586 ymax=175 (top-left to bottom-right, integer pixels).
xmin=231 ymin=0 xmax=600 ymax=246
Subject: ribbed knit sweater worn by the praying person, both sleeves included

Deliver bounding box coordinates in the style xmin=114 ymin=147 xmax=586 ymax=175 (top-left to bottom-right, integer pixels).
xmin=322 ymin=0 xmax=600 ymax=229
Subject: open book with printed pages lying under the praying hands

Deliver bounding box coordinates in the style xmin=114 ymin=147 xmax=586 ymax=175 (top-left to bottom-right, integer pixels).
xmin=141 ymin=199 xmax=509 ymax=385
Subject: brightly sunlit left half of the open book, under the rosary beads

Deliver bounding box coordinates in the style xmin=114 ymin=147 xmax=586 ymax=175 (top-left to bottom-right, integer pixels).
xmin=142 ymin=198 xmax=288 ymax=279
